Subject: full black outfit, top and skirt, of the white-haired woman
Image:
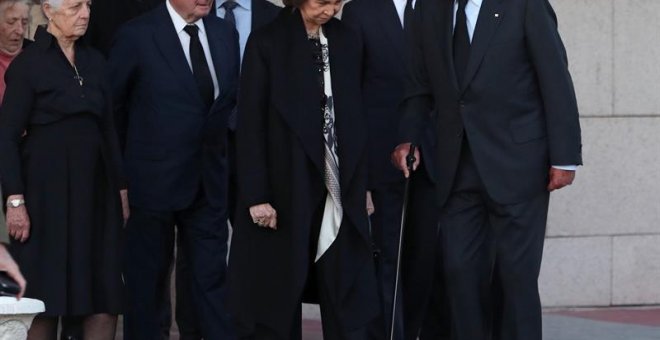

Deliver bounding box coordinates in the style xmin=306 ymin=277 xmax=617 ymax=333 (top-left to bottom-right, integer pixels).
xmin=0 ymin=30 xmax=123 ymax=316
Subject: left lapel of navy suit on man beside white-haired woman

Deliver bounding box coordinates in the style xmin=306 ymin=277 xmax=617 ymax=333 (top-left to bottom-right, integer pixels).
xmin=153 ymin=4 xmax=202 ymax=103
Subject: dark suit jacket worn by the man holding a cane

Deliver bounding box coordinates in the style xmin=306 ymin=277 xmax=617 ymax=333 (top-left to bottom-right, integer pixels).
xmin=401 ymin=0 xmax=582 ymax=204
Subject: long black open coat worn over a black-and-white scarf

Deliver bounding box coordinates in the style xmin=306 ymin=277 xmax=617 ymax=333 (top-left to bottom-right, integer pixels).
xmin=229 ymin=8 xmax=378 ymax=338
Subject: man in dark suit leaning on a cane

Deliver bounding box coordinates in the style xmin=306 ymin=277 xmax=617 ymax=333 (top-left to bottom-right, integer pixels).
xmin=393 ymin=0 xmax=582 ymax=340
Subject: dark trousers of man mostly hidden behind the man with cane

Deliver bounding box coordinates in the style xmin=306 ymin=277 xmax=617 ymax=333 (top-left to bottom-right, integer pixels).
xmin=371 ymin=181 xmax=405 ymax=339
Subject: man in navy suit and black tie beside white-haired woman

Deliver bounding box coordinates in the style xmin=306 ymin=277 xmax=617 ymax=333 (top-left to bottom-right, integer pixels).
xmin=109 ymin=0 xmax=239 ymax=339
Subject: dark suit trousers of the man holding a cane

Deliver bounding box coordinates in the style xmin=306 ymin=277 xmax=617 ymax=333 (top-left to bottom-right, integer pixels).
xmin=440 ymin=143 xmax=549 ymax=340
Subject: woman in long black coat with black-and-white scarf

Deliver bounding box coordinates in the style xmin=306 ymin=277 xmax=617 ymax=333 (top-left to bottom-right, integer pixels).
xmin=229 ymin=0 xmax=379 ymax=340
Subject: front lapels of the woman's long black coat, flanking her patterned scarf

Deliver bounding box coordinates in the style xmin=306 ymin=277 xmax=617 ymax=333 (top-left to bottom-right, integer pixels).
xmin=278 ymin=9 xmax=366 ymax=202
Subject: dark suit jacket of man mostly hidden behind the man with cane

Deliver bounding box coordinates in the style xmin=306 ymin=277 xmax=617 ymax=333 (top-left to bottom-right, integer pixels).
xmin=342 ymin=0 xmax=435 ymax=188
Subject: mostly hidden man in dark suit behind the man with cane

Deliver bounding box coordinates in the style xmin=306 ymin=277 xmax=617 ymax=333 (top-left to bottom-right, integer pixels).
xmin=342 ymin=0 xmax=452 ymax=339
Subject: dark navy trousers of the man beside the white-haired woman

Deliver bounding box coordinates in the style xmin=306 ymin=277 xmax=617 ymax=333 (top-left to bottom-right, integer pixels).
xmin=124 ymin=191 xmax=234 ymax=340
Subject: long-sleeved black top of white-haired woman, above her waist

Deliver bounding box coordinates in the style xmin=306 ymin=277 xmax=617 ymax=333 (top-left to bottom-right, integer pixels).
xmin=0 ymin=29 xmax=122 ymax=197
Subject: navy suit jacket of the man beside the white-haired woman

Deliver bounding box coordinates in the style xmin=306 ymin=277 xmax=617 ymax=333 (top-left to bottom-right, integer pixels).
xmin=109 ymin=4 xmax=239 ymax=211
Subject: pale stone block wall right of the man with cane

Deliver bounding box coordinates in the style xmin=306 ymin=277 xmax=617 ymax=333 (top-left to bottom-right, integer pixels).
xmin=540 ymin=0 xmax=660 ymax=306
